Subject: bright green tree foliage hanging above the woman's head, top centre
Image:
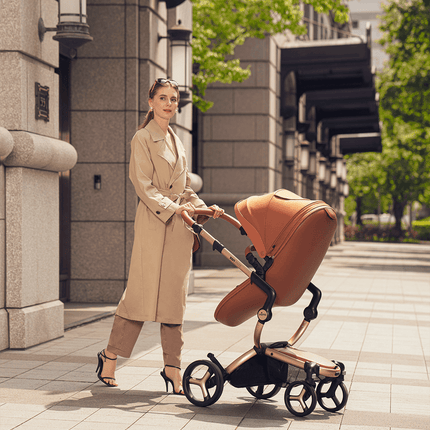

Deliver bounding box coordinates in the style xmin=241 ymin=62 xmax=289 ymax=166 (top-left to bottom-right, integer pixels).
xmin=192 ymin=0 xmax=348 ymax=112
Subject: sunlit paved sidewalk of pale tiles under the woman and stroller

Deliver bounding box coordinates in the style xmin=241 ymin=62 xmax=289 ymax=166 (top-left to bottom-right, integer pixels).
xmin=0 ymin=242 xmax=430 ymax=430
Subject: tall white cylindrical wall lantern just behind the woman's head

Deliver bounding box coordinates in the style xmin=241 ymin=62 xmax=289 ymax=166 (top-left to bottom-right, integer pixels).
xmin=158 ymin=20 xmax=193 ymax=110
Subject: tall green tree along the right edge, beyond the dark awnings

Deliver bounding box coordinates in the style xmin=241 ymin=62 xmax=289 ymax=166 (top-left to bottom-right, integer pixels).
xmin=377 ymin=0 xmax=430 ymax=232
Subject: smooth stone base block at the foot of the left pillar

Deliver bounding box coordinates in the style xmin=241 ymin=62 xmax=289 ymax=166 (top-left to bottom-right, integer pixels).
xmin=7 ymin=300 xmax=64 ymax=349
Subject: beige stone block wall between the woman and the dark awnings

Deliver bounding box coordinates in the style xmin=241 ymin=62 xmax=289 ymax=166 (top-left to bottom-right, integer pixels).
xmin=196 ymin=37 xmax=282 ymax=266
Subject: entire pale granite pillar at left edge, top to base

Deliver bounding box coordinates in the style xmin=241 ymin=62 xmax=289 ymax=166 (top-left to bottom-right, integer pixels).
xmin=0 ymin=0 xmax=77 ymax=349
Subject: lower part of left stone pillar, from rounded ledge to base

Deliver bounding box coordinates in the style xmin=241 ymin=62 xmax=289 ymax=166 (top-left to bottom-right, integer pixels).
xmin=4 ymin=131 xmax=77 ymax=349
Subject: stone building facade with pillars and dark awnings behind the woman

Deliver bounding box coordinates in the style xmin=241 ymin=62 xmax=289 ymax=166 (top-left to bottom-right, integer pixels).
xmin=0 ymin=0 xmax=380 ymax=350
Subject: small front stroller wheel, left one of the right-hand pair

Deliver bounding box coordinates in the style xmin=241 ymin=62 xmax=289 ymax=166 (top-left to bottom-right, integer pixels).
xmin=284 ymin=381 xmax=317 ymax=417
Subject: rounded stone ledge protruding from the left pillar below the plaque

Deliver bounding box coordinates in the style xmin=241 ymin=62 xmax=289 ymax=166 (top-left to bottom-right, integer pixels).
xmin=4 ymin=131 xmax=78 ymax=172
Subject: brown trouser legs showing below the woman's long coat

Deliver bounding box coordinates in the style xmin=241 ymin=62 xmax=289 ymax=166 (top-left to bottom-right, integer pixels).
xmin=106 ymin=315 xmax=184 ymax=367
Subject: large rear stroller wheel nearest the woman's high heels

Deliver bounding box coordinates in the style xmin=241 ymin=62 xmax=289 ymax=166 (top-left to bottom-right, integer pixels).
xmin=182 ymin=360 xmax=224 ymax=406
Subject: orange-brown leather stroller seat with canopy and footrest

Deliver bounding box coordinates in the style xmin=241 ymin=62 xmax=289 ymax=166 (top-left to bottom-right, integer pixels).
xmin=215 ymin=190 xmax=337 ymax=326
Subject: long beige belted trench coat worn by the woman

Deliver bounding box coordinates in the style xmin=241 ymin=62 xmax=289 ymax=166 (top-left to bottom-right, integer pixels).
xmin=116 ymin=120 xmax=206 ymax=324
